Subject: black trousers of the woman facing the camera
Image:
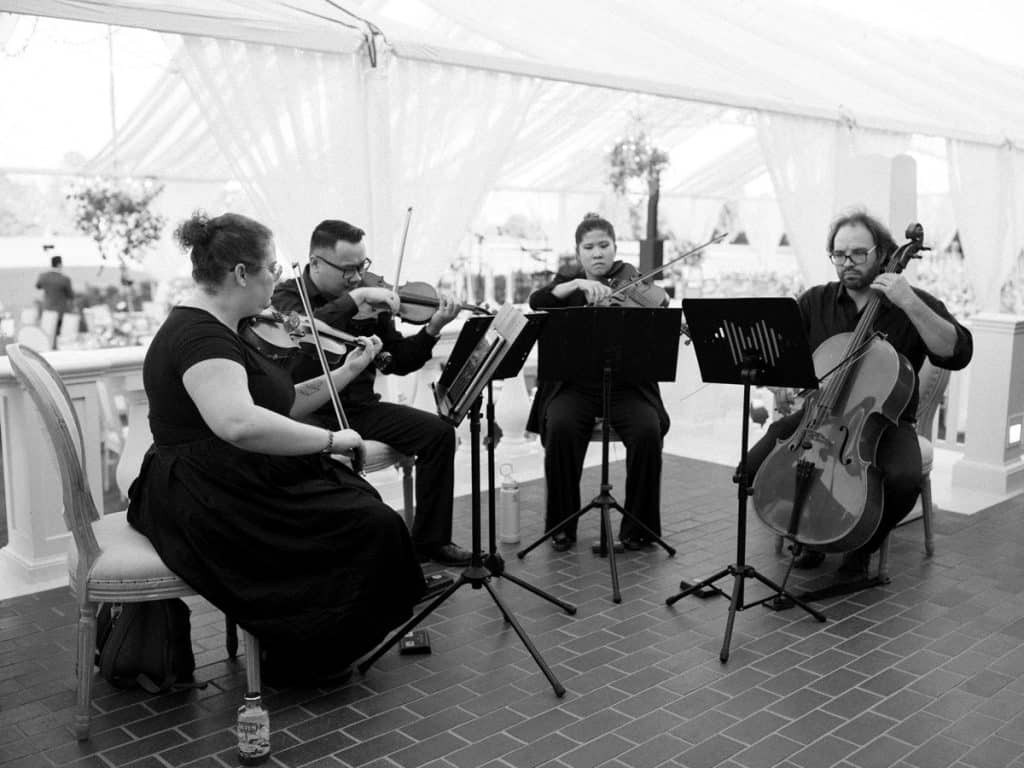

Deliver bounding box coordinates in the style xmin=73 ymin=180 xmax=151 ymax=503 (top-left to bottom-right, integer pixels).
xmin=544 ymin=384 xmax=662 ymax=539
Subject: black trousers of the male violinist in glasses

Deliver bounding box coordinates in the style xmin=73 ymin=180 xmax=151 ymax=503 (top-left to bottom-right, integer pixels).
xmin=317 ymin=400 xmax=456 ymax=549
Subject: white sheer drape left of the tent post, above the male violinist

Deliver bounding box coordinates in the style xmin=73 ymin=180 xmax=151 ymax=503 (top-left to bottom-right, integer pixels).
xmin=177 ymin=37 xmax=372 ymax=273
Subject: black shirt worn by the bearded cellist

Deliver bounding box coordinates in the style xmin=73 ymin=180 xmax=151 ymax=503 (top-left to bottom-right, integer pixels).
xmin=798 ymin=283 xmax=974 ymax=416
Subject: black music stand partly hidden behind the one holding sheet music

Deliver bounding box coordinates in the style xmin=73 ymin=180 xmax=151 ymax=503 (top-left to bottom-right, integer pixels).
xmin=437 ymin=312 xmax=577 ymax=615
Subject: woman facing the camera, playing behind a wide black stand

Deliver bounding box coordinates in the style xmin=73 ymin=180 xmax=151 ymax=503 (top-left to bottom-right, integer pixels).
xmin=526 ymin=214 xmax=669 ymax=552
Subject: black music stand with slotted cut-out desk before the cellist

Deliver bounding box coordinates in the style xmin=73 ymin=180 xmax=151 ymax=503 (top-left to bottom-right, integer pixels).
xmin=666 ymin=298 xmax=825 ymax=664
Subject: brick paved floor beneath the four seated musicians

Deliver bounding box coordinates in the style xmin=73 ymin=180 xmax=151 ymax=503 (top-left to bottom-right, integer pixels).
xmin=0 ymin=457 xmax=1024 ymax=768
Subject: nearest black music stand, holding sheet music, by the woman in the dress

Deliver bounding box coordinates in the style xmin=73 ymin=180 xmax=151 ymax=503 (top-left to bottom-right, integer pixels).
xmin=358 ymin=305 xmax=571 ymax=696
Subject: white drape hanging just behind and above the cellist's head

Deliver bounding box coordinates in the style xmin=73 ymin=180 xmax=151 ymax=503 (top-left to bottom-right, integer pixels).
xmin=758 ymin=113 xmax=842 ymax=285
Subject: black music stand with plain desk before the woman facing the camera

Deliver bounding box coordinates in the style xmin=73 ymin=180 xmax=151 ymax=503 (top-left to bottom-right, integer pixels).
xmin=517 ymin=307 xmax=682 ymax=603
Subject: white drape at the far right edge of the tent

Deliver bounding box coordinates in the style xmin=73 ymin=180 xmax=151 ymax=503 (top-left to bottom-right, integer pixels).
xmin=947 ymin=140 xmax=1024 ymax=311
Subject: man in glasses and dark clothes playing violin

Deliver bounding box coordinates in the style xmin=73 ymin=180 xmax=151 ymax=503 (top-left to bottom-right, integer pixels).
xmin=272 ymin=219 xmax=470 ymax=565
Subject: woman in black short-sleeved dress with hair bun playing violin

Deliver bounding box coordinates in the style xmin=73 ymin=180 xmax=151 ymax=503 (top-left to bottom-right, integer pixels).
xmin=128 ymin=213 xmax=425 ymax=682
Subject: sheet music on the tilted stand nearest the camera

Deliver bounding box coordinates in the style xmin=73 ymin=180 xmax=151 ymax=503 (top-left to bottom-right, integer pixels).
xmin=434 ymin=304 xmax=529 ymax=426
